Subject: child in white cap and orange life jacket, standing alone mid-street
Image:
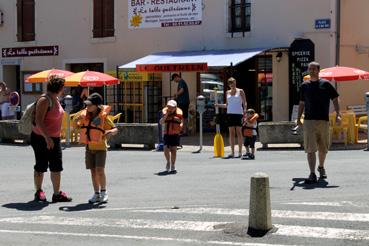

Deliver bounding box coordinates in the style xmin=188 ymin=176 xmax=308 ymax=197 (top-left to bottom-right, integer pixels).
xmin=160 ymin=100 xmax=183 ymax=174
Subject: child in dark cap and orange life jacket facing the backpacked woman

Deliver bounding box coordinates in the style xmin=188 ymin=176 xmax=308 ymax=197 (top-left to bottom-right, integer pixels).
xmin=77 ymin=93 xmax=118 ymax=203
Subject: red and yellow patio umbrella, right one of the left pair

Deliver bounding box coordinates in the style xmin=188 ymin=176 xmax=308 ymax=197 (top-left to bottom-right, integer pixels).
xmin=65 ymin=71 xmax=119 ymax=87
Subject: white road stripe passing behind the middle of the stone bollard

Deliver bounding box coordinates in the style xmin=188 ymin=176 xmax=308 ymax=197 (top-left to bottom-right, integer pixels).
xmin=131 ymin=208 xmax=369 ymax=222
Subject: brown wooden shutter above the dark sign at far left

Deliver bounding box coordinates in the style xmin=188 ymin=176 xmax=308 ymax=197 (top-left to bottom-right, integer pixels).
xmin=22 ymin=0 xmax=35 ymax=41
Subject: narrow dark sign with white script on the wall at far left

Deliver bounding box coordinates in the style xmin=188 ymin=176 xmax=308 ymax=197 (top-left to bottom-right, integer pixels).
xmin=1 ymin=45 xmax=59 ymax=57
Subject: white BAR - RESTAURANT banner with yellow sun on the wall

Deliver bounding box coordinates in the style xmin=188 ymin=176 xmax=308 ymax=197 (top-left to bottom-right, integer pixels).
xmin=128 ymin=0 xmax=202 ymax=29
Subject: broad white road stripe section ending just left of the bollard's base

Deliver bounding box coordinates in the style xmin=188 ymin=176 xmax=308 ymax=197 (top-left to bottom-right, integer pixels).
xmin=0 ymin=215 xmax=218 ymax=231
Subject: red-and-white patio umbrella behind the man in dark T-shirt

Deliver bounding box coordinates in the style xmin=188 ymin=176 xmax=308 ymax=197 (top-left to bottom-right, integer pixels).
xmin=304 ymin=66 xmax=369 ymax=82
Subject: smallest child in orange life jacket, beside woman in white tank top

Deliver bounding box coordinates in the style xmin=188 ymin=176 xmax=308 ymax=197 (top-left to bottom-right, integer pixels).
xmin=242 ymin=108 xmax=259 ymax=160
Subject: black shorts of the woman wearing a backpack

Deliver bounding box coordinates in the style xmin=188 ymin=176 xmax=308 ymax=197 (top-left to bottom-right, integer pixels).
xmin=31 ymin=132 xmax=63 ymax=173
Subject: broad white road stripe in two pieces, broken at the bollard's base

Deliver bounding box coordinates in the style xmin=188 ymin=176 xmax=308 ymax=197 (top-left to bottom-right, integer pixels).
xmin=0 ymin=216 xmax=369 ymax=240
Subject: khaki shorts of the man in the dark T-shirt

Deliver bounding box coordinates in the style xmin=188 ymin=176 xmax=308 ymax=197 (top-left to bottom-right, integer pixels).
xmin=303 ymin=120 xmax=331 ymax=153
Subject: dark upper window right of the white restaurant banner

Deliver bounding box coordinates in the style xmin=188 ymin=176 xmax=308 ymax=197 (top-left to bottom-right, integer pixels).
xmin=229 ymin=0 xmax=251 ymax=33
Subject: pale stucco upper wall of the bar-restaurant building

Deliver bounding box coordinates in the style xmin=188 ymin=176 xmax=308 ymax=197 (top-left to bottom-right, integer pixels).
xmin=0 ymin=0 xmax=336 ymax=119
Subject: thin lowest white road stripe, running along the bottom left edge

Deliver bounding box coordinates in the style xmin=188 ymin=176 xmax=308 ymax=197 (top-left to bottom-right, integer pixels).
xmin=0 ymin=230 xmax=292 ymax=246
